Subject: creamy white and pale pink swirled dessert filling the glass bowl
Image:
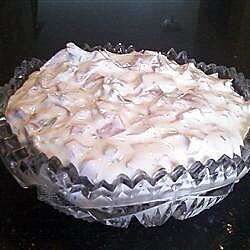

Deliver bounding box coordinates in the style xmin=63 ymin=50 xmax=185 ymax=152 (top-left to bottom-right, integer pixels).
xmin=6 ymin=43 xmax=250 ymax=181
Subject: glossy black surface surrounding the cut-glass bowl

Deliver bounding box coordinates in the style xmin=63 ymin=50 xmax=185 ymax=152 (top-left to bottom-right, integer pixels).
xmin=0 ymin=0 xmax=250 ymax=250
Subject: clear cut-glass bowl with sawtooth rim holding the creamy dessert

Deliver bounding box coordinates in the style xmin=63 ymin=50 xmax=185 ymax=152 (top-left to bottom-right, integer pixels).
xmin=0 ymin=43 xmax=250 ymax=227
